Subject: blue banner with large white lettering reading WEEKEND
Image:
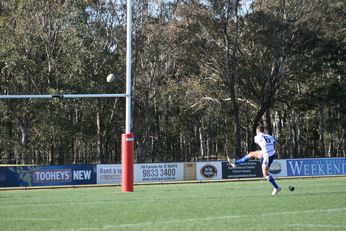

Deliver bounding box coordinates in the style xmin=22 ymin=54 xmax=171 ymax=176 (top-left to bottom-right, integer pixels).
xmin=286 ymin=158 xmax=346 ymax=176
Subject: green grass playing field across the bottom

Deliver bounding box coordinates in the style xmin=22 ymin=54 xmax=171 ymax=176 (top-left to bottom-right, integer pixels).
xmin=0 ymin=177 xmax=346 ymax=231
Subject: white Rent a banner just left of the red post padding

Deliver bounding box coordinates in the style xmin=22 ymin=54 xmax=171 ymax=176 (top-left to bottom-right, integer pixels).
xmin=97 ymin=164 xmax=121 ymax=184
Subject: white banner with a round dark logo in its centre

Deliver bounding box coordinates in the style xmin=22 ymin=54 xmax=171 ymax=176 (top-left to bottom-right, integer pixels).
xmin=196 ymin=161 xmax=222 ymax=180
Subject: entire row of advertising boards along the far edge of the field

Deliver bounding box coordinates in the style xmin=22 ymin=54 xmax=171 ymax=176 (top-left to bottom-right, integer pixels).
xmin=0 ymin=158 xmax=346 ymax=187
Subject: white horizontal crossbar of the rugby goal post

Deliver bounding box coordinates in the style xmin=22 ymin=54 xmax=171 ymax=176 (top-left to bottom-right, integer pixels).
xmin=0 ymin=94 xmax=128 ymax=100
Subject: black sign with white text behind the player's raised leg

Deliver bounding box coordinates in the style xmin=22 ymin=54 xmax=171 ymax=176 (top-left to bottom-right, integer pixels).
xmin=222 ymin=160 xmax=263 ymax=179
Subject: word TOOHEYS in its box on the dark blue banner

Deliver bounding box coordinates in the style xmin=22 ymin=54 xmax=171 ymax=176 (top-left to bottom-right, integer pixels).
xmin=32 ymin=169 xmax=72 ymax=183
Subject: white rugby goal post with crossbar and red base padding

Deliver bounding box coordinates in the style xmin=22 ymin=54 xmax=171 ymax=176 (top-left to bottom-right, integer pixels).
xmin=0 ymin=0 xmax=134 ymax=192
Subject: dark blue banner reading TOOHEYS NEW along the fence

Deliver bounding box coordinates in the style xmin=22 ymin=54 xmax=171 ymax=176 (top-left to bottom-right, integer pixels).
xmin=0 ymin=165 xmax=96 ymax=187
